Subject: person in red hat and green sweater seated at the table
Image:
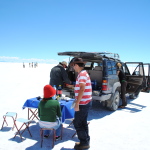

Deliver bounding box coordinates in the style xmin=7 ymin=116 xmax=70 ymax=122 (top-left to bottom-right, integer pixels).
xmin=38 ymin=85 xmax=61 ymax=140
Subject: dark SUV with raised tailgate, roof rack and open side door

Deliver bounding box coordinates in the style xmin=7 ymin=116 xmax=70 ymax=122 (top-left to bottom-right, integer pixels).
xmin=58 ymin=52 xmax=149 ymax=110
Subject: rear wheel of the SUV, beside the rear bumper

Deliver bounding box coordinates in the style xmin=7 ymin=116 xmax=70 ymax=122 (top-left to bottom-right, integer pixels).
xmin=110 ymin=91 xmax=120 ymax=110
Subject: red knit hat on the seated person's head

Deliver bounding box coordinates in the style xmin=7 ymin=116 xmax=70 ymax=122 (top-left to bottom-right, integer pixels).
xmin=43 ymin=85 xmax=56 ymax=98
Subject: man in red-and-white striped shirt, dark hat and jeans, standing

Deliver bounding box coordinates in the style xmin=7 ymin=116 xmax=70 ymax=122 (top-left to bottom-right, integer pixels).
xmin=71 ymin=58 xmax=92 ymax=149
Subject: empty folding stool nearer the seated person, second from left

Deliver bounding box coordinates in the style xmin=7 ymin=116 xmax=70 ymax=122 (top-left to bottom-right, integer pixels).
xmin=14 ymin=118 xmax=32 ymax=140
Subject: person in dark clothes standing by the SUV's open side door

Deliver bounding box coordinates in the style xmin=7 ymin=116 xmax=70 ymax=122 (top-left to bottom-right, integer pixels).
xmin=117 ymin=62 xmax=127 ymax=108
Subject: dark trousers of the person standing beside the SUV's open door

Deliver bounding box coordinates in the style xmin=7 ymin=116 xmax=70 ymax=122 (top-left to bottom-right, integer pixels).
xmin=121 ymin=81 xmax=127 ymax=106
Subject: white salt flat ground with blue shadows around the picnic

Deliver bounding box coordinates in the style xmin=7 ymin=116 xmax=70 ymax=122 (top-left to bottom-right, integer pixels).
xmin=0 ymin=62 xmax=150 ymax=150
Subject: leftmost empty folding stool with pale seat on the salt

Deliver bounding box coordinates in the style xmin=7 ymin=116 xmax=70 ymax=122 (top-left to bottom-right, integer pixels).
xmin=1 ymin=112 xmax=17 ymax=130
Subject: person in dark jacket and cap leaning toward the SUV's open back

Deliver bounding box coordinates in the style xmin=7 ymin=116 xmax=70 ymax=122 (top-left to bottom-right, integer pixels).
xmin=49 ymin=61 xmax=71 ymax=88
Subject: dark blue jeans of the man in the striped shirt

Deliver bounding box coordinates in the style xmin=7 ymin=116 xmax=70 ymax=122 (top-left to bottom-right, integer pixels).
xmin=73 ymin=103 xmax=90 ymax=145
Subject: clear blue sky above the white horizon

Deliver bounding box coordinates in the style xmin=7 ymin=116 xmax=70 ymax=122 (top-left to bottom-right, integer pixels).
xmin=0 ymin=0 xmax=150 ymax=63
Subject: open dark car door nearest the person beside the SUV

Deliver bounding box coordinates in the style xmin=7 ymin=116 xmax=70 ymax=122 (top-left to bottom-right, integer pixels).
xmin=123 ymin=62 xmax=146 ymax=97
